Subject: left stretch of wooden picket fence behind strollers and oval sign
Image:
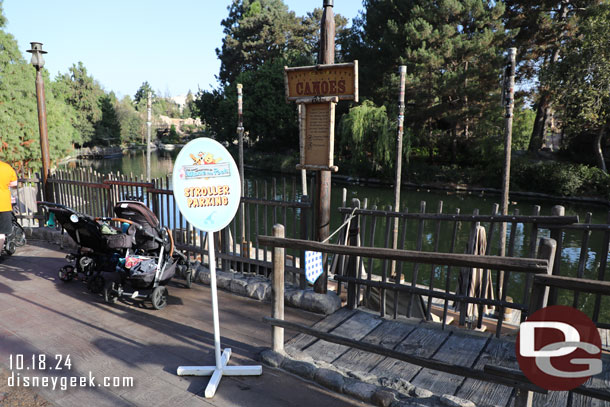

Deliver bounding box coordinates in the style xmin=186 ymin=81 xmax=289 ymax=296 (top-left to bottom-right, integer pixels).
xmin=35 ymin=170 xmax=313 ymax=288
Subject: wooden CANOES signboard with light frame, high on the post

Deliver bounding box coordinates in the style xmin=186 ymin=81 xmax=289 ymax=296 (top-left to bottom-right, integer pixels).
xmin=284 ymin=60 xmax=358 ymax=103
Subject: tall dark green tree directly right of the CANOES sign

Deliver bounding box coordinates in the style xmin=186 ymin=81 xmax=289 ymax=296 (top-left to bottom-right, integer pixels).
xmin=346 ymin=0 xmax=507 ymax=166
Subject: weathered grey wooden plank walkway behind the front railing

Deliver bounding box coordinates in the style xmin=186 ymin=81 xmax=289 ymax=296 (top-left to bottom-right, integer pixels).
xmin=285 ymin=308 xmax=610 ymax=407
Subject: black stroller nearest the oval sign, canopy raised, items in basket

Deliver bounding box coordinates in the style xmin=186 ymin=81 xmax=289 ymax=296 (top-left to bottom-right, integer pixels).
xmin=101 ymin=201 xmax=193 ymax=309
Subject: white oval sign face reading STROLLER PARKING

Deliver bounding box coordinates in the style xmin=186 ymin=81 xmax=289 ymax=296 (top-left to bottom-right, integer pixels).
xmin=173 ymin=138 xmax=241 ymax=232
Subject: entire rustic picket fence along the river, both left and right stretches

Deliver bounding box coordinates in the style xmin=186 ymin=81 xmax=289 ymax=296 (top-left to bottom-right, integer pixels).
xmin=11 ymin=169 xmax=610 ymax=327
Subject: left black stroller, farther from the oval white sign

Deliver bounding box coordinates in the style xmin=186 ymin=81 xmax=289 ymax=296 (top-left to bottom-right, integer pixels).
xmin=38 ymin=202 xmax=136 ymax=293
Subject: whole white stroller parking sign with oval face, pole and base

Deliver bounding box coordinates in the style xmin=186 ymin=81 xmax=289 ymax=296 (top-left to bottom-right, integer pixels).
xmin=173 ymin=138 xmax=263 ymax=398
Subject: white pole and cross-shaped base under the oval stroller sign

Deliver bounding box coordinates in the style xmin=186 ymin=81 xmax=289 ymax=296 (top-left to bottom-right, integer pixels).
xmin=178 ymin=237 xmax=263 ymax=398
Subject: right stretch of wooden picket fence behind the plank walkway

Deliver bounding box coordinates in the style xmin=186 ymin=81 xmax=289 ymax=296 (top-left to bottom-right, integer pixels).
xmin=331 ymin=200 xmax=610 ymax=328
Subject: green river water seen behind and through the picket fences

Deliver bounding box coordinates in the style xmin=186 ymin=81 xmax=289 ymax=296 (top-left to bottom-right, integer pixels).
xmin=63 ymin=151 xmax=610 ymax=322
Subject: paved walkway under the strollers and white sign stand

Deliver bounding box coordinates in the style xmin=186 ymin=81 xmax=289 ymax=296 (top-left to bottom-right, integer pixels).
xmin=0 ymin=242 xmax=365 ymax=407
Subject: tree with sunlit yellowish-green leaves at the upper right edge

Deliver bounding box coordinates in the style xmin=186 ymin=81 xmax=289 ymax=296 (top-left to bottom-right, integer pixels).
xmin=544 ymin=3 xmax=610 ymax=172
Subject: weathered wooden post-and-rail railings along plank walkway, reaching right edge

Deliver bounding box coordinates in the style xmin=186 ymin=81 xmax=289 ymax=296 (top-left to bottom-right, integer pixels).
xmin=259 ymin=225 xmax=610 ymax=407
